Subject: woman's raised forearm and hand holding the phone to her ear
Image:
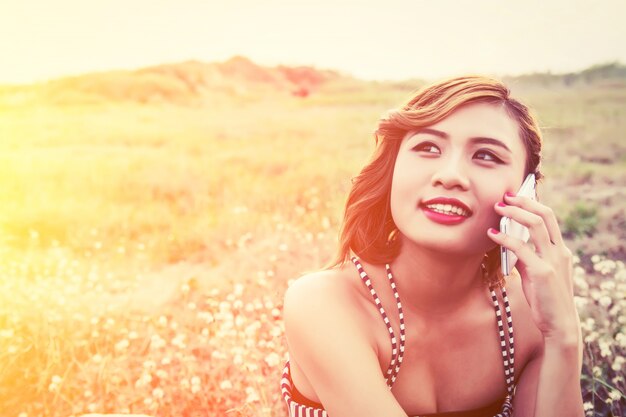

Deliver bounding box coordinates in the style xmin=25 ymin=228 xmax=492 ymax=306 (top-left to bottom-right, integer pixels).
xmin=489 ymin=195 xmax=584 ymax=417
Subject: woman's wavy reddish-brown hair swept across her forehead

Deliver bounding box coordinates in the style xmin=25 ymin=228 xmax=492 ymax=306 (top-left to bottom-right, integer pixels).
xmin=328 ymin=76 xmax=543 ymax=286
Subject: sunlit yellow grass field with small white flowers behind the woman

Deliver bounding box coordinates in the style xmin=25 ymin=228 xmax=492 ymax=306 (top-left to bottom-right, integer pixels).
xmin=0 ymin=69 xmax=626 ymax=417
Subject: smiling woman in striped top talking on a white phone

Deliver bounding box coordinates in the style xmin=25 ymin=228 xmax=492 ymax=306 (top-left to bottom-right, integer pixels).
xmin=281 ymin=77 xmax=584 ymax=417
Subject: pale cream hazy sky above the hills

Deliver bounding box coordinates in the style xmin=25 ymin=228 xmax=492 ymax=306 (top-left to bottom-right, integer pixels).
xmin=0 ymin=0 xmax=626 ymax=84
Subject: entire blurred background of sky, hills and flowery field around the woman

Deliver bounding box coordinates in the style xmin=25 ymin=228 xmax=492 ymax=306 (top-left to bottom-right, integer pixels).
xmin=0 ymin=0 xmax=626 ymax=417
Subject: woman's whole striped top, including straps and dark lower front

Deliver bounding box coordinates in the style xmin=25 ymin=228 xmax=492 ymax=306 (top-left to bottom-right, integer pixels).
xmin=281 ymin=257 xmax=515 ymax=417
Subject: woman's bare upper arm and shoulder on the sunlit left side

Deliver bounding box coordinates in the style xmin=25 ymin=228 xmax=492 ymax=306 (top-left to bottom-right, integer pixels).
xmin=284 ymin=271 xmax=407 ymax=417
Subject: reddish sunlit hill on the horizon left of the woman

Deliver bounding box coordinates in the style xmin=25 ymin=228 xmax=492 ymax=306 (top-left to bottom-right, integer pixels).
xmin=0 ymin=56 xmax=346 ymax=105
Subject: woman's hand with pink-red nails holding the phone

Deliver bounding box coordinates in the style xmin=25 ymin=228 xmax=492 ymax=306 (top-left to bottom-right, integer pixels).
xmin=487 ymin=193 xmax=581 ymax=346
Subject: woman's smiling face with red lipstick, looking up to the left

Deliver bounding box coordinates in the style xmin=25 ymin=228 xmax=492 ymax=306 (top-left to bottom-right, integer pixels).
xmin=391 ymin=103 xmax=527 ymax=254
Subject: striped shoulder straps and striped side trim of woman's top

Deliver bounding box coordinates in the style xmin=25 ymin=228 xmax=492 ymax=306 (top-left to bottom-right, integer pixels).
xmin=281 ymin=257 xmax=515 ymax=417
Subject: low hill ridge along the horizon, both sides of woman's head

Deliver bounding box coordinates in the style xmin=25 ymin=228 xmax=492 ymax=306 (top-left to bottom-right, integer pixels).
xmin=0 ymin=56 xmax=626 ymax=107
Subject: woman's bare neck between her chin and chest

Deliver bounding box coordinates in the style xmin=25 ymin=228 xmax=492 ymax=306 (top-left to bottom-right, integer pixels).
xmin=391 ymin=237 xmax=487 ymax=318
